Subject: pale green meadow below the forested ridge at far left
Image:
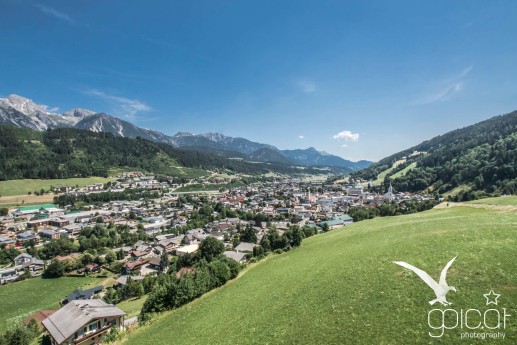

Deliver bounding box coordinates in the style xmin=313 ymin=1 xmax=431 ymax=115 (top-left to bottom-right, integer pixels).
xmin=0 ymin=176 xmax=114 ymax=196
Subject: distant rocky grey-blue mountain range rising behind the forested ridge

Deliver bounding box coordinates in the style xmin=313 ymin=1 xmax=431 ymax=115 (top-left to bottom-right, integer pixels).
xmin=0 ymin=94 xmax=372 ymax=171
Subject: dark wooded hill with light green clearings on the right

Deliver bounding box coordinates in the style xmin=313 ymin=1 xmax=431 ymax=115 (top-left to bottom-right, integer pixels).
xmin=353 ymin=111 xmax=517 ymax=201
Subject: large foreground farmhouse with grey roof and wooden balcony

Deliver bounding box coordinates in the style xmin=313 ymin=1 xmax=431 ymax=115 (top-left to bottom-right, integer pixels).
xmin=42 ymin=299 xmax=126 ymax=345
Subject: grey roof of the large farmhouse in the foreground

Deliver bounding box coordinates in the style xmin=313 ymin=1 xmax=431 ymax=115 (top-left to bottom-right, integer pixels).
xmin=42 ymin=299 xmax=126 ymax=344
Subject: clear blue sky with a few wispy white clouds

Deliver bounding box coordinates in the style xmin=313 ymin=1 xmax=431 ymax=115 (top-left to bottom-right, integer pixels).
xmin=0 ymin=0 xmax=517 ymax=160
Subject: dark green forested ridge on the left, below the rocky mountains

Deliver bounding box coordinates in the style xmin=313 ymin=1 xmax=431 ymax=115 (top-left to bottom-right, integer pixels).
xmin=0 ymin=126 xmax=330 ymax=180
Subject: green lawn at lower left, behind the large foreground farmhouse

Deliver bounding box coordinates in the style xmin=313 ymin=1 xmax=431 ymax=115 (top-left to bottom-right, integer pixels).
xmin=0 ymin=277 xmax=105 ymax=334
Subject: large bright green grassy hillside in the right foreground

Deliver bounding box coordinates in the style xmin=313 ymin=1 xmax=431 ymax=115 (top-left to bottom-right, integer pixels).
xmin=126 ymin=202 xmax=517 ymax=345
